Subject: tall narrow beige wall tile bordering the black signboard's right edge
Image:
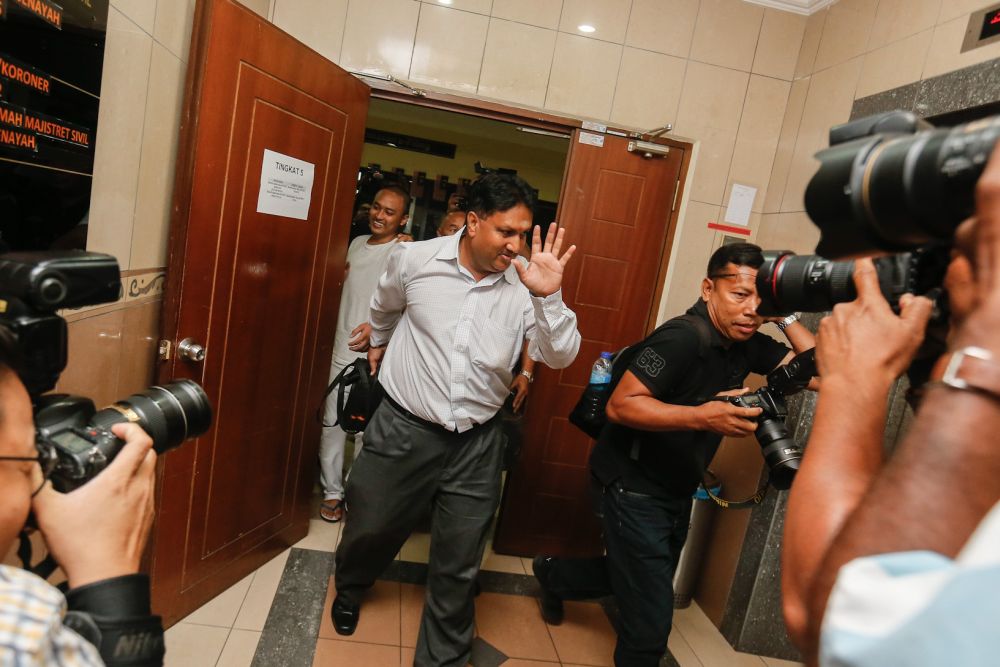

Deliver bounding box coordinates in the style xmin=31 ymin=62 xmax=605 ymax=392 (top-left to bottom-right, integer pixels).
xmin=87 ymin=8 xmax=153 ymax=269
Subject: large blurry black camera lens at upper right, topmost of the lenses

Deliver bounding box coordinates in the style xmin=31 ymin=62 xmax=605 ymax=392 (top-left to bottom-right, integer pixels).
xmin=805 ymin=116 xmax=1000 ymax=258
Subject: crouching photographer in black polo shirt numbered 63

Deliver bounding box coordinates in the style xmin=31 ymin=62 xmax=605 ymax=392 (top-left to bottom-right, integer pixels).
xmin=533 ymin=243 xmax=814 ymax=667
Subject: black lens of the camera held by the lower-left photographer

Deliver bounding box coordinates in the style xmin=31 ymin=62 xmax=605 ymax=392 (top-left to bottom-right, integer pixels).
xmin=91 ymin=380 xmax=212 ymax=454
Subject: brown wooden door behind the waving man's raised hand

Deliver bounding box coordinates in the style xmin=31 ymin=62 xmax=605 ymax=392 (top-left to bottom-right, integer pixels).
xmin=494 ymin=130 xmax=684 ymax=556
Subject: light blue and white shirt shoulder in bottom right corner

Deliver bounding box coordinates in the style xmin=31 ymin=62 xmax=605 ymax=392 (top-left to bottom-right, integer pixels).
xmin=820 ymin=504 xmax=1000 ymax=667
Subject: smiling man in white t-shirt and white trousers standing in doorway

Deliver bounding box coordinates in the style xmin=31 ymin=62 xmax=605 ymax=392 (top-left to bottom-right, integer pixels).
xmin=319 ymin=185 xmax=410 ymax=523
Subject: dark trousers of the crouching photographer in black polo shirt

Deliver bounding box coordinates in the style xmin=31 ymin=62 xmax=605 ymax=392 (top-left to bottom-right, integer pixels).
xmin=544 ymin=483 xmax=691 ymax=667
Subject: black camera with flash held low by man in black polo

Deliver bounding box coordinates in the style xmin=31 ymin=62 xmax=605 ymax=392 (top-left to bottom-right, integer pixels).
xmin=715 ymin=350 xmax=816 ymax=491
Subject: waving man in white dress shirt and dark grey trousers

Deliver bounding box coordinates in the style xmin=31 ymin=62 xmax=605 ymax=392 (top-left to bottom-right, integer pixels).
xmin=332 ymin=174 xmax=580 ymax=665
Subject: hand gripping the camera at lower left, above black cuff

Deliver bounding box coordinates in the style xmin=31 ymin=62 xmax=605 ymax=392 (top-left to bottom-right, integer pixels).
xmin=33 ymin=424 xmax=156 ymax=588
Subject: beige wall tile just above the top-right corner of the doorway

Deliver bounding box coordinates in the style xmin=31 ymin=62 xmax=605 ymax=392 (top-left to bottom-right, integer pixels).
xmin=677 ymin=62 xmax=750 ymax=132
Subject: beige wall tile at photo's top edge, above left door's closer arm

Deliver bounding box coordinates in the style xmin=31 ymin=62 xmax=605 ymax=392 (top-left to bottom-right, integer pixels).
xmin=340 ymin=0 xmax=420 ymax=79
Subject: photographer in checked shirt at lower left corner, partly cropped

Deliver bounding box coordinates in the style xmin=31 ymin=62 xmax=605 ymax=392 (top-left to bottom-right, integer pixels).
xmin=0 ymin=327 xmax=164 ymax=665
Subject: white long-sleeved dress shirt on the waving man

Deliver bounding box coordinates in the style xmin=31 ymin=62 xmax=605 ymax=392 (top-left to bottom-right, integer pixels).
xmin=370 ymin=230 xmax=580 ymax=432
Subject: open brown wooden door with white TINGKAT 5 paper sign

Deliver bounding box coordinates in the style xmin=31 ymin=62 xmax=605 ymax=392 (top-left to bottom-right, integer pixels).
xmin=152 ymin=0 xmax=369 ymax=622
